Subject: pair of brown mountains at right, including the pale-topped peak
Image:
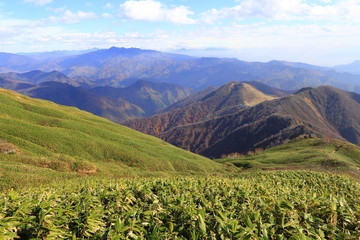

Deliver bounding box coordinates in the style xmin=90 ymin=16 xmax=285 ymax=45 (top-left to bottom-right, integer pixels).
xmin=125 ymin=82 xmax=360 ymax=158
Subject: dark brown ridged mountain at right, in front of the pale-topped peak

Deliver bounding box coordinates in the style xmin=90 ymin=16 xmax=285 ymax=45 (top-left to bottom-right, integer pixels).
xmin=201 ymin=87 xmax=360 ymax=156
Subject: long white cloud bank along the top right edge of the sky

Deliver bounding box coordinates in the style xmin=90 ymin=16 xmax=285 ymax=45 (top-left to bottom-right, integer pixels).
xmin=202 ymin=0 xmax=360 ymax=23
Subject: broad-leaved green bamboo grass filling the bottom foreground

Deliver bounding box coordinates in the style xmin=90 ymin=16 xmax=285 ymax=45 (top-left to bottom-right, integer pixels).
xmin=0 ymin=172 xmax=360 ymax=239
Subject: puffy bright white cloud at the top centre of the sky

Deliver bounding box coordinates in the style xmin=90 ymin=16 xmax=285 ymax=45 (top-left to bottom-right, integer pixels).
xmin=119 ymin=0 xmax=195 ymax=24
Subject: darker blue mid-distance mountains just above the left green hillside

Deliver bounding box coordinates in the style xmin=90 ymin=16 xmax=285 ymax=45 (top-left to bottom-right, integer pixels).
xmin=0 ymin=70 xmax=192 ymax=123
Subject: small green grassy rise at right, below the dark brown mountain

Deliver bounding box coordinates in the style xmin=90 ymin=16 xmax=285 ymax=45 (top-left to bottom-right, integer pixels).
xmin=217 ymin=138 xmax=360 ymax=178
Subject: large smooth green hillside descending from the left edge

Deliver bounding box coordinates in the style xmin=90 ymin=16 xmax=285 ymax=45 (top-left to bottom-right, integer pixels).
xmin=0 ymin=89 xmax=223 ymax=187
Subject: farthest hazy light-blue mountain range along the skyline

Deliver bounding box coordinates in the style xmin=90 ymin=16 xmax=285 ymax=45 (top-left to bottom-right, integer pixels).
xmin=0 ymin=47 xmax=360 ymax=92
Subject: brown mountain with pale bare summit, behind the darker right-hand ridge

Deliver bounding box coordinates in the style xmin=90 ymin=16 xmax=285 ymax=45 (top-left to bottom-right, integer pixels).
xmin=124 ymin=82 xmax=275 ymax=137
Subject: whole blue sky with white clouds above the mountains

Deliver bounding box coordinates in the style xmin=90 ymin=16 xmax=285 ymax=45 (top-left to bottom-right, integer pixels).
xmin=0 ymin=0 xmax=360 ymax=66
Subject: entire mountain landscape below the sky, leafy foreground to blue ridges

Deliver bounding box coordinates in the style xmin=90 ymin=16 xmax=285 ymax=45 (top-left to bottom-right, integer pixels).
xmin=0 ymin=47 xmax=360 ymax=240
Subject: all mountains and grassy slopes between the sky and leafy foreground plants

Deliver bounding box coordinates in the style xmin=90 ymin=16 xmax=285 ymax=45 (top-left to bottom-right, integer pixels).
xmin=0 ymin=47 xmax=360 ymax=185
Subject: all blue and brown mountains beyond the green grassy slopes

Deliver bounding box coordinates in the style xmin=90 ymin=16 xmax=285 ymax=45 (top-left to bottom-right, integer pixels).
xmin=0 ymin=47 xmax=360 ymax=157
